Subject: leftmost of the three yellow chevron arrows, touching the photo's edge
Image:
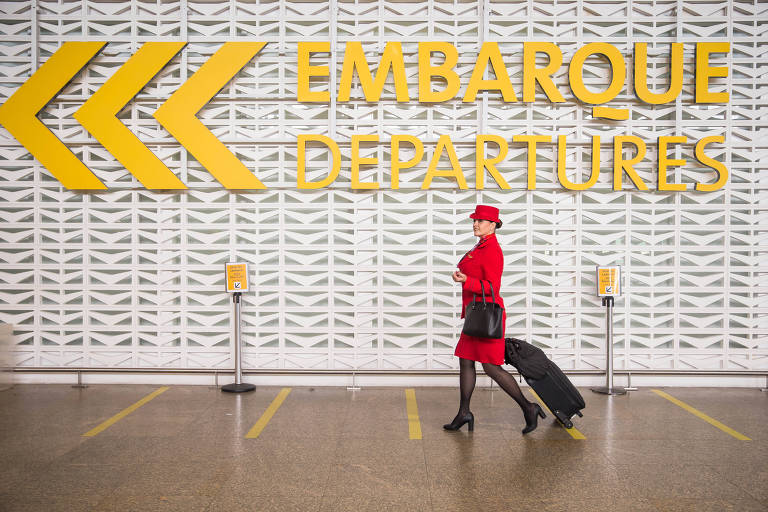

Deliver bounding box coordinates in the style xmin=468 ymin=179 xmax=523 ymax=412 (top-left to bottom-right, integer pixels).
xmin=0 ymin=41 xmax=107 ymax=190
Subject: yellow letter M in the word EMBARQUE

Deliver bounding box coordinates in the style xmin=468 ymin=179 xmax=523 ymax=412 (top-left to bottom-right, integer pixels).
xmin=337 ymin=41 xmax=411 ymax=102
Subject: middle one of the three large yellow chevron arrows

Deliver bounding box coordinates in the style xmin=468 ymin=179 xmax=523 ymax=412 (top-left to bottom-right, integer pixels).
xmin=74 ymin=42 xmax=187 ymax=189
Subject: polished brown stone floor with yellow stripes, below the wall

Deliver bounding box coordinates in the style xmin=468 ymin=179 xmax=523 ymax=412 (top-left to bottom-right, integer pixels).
xmin=0 ymin=385 xmax=768 ymax=512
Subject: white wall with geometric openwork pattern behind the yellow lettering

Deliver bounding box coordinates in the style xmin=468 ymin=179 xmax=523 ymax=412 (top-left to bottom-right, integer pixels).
xmin=0 ymin=0 xmax=768 ymax=376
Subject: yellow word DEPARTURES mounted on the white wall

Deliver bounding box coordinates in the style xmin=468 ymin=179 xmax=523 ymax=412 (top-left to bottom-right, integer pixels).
xmin=296 ymin=134 xmax=729 ymax=192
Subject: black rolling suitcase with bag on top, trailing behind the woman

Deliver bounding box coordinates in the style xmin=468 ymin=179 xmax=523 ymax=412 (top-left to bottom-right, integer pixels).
xmin=504 ymin=338 xmax=585 ymax=428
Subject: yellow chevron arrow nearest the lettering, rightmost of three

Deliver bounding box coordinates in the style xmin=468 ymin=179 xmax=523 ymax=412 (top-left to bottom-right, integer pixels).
xmin=154 ymin=42 xmax=267 ymax=189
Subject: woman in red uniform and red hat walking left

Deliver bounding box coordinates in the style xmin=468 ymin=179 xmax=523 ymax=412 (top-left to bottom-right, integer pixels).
xmin=443 ymin=205 xmax=545 ymax=434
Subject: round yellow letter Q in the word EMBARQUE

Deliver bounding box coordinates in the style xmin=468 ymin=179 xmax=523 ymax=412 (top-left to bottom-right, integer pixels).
xmin=568 ymin=43 xmax=627 ymax=105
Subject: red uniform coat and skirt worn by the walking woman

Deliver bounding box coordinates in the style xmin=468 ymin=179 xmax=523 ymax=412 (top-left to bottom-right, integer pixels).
xmin=454 ymin=234 xmax=507 ymax=365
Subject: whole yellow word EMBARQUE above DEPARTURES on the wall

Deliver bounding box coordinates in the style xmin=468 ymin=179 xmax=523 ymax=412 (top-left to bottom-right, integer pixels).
xmin=297 ymin=41 xmax=730 ymax=107
